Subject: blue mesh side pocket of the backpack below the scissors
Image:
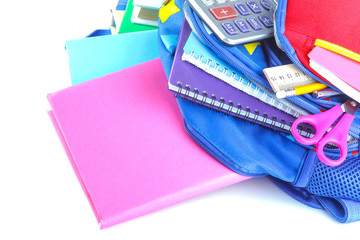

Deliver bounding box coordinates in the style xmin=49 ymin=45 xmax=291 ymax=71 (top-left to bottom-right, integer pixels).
xmin=307 ymin=157 xmax=360 ymax=201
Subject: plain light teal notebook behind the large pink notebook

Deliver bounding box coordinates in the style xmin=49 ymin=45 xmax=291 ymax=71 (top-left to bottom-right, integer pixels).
xmin=65 ymin=30 xmax=159 ymax=85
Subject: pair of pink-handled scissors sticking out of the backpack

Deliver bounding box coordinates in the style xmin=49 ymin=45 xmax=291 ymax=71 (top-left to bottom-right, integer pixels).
xmin=291 ymin=101 xmax=359 ymax=167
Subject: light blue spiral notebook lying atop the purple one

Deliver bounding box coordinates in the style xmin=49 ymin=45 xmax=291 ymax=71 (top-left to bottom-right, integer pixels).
xmin=182 ymin=32 xmax=309 ymax=118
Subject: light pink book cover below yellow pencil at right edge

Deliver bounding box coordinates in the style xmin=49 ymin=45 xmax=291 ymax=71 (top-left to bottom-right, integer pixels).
xmin=308 ymin=47 xmax=360 ymax=91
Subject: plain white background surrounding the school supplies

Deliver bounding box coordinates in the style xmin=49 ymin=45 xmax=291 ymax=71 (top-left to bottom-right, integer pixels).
xmin=0 ymin=0 xmax=360 ymax=240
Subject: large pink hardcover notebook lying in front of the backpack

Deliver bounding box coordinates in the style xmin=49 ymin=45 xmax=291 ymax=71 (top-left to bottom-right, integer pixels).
xmin=48 ymin=59 xmax=247 ymax=228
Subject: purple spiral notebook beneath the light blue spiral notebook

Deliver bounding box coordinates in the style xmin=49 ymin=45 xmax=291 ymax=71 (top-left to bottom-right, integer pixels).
xmin=168 ymin=21 xmax=295 ymax=133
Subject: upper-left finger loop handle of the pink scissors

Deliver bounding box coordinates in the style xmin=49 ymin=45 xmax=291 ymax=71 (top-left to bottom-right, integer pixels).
xmin=291 ymin=105 xmax=343 ymax=145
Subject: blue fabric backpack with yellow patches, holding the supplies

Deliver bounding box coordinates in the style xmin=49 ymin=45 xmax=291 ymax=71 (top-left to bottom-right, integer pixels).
xmin=159 ymin=0 xmax=360 ymax=223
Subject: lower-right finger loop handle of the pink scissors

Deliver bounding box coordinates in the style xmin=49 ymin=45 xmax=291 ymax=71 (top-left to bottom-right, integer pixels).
xmin=316 ymin=114 xmax=354 ymax=167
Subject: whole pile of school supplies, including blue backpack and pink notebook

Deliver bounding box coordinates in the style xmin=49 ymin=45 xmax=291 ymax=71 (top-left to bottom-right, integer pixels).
xmin=48 ymin=0 xmax=360 ymax=228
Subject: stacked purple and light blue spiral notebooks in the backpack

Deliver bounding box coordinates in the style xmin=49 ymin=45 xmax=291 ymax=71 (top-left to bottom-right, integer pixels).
xmin=168 ymin=21 xmax=306 ymax=133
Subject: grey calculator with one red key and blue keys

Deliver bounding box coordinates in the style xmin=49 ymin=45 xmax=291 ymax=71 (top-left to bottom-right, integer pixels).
xmin=186 ymin=0 xmax=277 ymax=45
